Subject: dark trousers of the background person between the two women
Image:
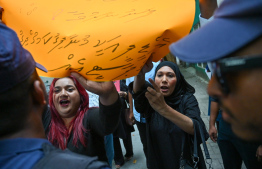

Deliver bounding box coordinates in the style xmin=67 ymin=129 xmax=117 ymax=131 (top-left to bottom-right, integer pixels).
xmin=114 ymin=132 xmax=134 ymax=165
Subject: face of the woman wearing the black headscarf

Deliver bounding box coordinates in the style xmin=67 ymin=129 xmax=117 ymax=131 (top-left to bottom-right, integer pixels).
xmin=155 ymin=66 xmax=177 ymax=97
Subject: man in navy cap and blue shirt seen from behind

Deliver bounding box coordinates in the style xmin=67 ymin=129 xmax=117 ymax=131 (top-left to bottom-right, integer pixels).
xmin=0 ymin=23 xmax=107 ymax=169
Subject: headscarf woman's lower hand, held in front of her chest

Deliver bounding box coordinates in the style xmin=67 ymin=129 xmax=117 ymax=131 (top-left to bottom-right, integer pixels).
xmin=145 ymin=79 xmax=168 ymax=115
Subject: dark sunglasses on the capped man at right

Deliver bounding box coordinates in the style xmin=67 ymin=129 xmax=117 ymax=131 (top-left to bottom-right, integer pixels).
xmin=211 ymin=54 xmax=262 ymax=94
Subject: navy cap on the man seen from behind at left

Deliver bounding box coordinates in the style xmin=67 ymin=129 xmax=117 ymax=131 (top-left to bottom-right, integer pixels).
xmin=0 ymin=23 xmax=47 ymax=93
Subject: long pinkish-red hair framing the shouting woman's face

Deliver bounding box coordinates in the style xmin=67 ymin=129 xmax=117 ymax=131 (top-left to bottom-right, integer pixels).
xmin=48 ymin=76 xmax=89 ymax=150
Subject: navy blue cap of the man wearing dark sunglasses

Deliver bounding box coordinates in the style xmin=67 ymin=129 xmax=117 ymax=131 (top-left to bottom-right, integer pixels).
xmin=169 ymin=0 xmax=262 ymax=63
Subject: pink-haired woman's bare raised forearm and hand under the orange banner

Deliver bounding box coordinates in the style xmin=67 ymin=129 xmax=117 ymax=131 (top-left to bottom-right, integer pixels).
xmin=71 ymin=72 xmax=118 ymax=105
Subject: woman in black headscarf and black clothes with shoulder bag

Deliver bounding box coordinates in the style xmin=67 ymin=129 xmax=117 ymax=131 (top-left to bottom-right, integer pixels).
xmin=129 ymin=60 xmax=208 ymax=169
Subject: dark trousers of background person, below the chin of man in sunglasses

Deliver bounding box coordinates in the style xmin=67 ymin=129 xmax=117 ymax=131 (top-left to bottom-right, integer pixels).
xmin=218 ymin=119 xmax=262 ymax=169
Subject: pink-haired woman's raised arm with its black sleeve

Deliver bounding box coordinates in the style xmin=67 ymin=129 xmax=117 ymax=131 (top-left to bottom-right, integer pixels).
xmin=71 ymin=72 xmax=121 ymax=136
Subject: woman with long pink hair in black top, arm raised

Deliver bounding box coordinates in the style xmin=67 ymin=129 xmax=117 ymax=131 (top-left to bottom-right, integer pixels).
xmin=43 ymin=73 xmax=121 ymax=162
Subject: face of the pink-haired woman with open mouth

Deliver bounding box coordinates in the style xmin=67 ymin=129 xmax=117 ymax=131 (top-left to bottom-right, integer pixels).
xmin=53 ymin=77 xmax=80 ymax=118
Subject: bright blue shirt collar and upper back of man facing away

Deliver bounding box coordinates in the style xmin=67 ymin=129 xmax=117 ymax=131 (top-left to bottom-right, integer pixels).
xmin=0 ymin=138 xmax=51 ymax=169
